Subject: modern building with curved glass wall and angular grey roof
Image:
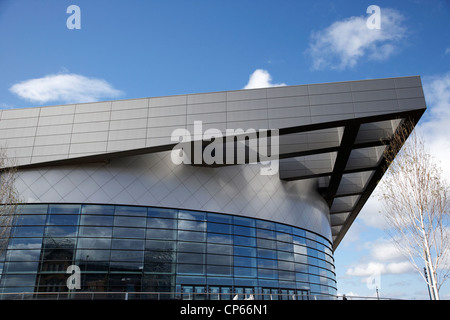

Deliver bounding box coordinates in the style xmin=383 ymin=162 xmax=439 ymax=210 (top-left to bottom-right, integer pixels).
xmin=0 ymin=76 xmax=426 ymax=299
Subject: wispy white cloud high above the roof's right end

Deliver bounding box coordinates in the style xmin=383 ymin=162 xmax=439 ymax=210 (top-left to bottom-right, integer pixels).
xmin=307 ymin=8 xmax=406 ymax=70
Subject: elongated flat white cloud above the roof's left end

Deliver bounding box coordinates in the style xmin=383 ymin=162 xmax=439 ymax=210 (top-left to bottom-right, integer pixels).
xmin=9 ymin=73 xmax=121 ymax=104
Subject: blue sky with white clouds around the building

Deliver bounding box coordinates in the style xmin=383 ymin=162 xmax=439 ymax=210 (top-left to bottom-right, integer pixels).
xmin=0 ymin=0 xmax=450 ymax=299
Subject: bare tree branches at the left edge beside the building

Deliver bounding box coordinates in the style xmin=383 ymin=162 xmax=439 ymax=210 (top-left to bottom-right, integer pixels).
xmin=0 ymin=148 xmax=20 ymax=256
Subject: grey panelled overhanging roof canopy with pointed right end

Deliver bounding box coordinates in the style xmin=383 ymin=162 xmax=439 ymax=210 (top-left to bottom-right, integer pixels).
xmin=0 ymin=76 xmax=426 ymax=248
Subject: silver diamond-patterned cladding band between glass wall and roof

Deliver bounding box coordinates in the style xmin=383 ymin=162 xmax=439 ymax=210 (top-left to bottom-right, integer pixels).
xmin=17 ymin=152 xmax=331 ymax=236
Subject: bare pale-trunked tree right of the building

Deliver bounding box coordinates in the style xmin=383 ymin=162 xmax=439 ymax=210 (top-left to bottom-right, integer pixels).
xmin=379 ymin=122 xmax=450 ymax=300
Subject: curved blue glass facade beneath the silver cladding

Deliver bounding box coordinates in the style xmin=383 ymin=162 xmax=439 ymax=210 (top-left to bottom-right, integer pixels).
xmin=0 ymin=204 xmax=336 ymax=299
